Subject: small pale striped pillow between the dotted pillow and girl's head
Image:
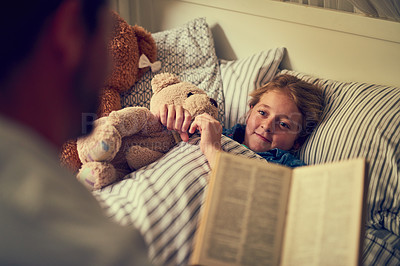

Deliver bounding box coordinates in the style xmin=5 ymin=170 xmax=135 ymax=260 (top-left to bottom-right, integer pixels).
xmin=220 ymin=47 xmax=285 ymax=128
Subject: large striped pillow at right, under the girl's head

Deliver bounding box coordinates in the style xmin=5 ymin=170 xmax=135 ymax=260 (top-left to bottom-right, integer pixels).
xmin=282 ymin=70 xmax=400 ymax=265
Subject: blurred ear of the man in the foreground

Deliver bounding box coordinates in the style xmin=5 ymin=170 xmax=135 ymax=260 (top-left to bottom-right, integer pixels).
xmin=51 ymin=0 xmax=86 ymax=69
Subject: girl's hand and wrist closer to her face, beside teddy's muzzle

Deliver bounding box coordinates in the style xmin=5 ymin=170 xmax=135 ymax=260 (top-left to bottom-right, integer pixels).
xmin=189 ymin=113 xmax=222 ymax=167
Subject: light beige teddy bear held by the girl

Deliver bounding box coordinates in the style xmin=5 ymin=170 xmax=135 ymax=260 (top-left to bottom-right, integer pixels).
xmin=77 ymin=73 xmax=218 ymax=189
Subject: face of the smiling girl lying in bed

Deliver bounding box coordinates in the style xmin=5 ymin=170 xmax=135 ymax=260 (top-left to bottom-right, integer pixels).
xmin=243 ymin=91 xmax=302 ymax=152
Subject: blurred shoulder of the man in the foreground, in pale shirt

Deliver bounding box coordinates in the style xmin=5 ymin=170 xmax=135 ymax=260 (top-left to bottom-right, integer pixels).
xmin=0 ymin=117 xmax=151 ymax=265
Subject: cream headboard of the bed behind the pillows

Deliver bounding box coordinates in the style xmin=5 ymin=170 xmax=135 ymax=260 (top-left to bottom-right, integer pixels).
xmin=131 ymin=0 xmax=400 ymax=86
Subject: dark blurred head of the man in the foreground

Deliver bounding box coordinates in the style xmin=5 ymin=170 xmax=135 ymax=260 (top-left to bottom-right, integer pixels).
xmin=0 ymin=0 xmax=111 ymax=145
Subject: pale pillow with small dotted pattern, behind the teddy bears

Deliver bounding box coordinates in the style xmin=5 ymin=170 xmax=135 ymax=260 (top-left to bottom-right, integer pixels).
xmin=121 ymin=18 xmax=224 ymax=121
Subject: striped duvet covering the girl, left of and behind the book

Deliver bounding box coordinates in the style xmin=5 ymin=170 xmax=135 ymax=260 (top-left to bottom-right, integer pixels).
xmin=94 ymin=136 xmax=264 ymax=265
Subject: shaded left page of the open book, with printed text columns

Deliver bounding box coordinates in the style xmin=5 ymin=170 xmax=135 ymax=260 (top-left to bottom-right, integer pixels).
xmin=193 ymin=153 xmax=291 ymax=265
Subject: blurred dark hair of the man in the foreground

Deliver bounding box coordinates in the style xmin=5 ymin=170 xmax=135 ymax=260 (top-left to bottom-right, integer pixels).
xmin=0 ymin=0 xmax=107 ymax=83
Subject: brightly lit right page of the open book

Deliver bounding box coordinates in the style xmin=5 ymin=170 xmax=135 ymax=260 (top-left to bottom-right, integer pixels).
xmin=282 ymin=159 xmax=365 ymax=265
